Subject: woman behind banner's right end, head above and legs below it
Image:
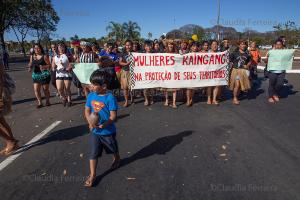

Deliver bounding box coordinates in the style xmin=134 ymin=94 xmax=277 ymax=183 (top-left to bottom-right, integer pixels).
xmin=206 ymin=40 xmax=220 ymax=105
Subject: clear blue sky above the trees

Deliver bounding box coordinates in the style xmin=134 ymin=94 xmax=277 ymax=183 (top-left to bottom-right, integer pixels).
xmin=5 ymin=0 xmax=300 ymax=40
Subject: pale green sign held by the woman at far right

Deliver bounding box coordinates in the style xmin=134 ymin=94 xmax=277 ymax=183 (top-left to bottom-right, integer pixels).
xmin=268 ymin=49 xmax=295 ymax=71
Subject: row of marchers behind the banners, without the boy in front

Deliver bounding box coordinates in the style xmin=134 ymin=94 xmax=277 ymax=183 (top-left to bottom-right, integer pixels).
xmin=28 ymin=35 xmax=285 ymax=108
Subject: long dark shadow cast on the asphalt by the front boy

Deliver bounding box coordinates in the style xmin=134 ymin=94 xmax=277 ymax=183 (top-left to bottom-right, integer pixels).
xmin=94 ymin=130 xmax=194 ymax=186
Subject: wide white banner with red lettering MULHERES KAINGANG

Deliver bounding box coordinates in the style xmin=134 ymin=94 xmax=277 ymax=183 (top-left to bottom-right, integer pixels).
xmin=130 ymin=52 xmax=229 ymax=89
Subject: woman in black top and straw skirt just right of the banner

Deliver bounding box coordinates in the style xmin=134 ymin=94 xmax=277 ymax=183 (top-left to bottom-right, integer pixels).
xmin=229 ymin=40 xmax=251 ymax=105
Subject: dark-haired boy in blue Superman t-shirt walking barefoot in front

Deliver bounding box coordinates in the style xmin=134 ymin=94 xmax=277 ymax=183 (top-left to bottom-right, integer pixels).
xmin=85 ymin=70 xmax=120 ymax=187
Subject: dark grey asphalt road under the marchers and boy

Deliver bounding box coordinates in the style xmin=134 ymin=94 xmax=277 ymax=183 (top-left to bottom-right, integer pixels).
xmin=0 ymin=63 xmax=300 ymax=200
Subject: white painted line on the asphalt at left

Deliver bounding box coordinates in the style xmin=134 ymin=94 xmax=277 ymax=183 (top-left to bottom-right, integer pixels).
xmin=0 ymin=121 xmax=61 ymax=171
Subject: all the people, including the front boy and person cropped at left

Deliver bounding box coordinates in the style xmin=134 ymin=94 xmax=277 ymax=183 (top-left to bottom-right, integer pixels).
xmin=0 ymin=35 xmax=296 ymax=187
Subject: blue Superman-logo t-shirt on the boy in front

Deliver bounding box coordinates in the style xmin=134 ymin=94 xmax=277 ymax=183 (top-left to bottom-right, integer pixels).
xmin=85 ymin=92 xmax=118 ymax=135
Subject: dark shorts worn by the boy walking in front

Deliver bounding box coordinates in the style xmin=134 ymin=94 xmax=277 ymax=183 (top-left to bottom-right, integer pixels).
xmin=90 ymin=133 xmax=119 ymax=160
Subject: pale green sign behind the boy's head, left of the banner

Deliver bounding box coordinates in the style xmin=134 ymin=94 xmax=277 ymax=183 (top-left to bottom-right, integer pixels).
xmin=73 ymin=63 xmax=99 ymax=84
